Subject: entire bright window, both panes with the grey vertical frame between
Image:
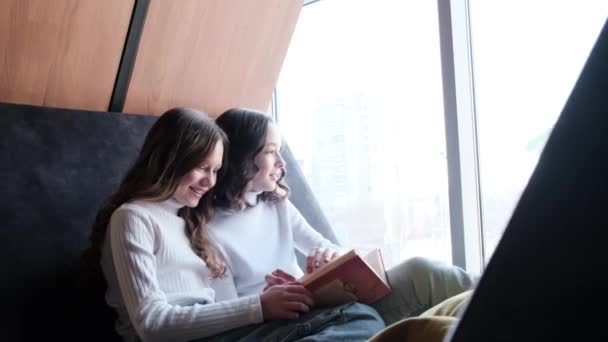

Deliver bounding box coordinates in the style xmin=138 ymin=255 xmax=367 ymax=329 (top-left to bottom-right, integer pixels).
xmin=274 ymin=0 xmax=608 ymax=272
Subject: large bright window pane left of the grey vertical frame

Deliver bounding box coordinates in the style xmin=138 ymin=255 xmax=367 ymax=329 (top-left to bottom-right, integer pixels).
xmin=276 ymin=0 xmax=451 ymax=266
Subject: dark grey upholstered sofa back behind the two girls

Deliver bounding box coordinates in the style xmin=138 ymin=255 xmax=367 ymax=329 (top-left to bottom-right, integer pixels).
xmin=0 ymin=103 xmax=335 ymax=341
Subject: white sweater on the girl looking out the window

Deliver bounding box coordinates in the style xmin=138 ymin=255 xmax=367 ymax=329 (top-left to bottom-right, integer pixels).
xmin=208 ymin=192 xmax=339 ymax=296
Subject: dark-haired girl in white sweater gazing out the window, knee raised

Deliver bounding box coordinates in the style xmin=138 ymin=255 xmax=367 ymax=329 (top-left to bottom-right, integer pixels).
xmin=209 ymin=108 xmax=473 ymax=325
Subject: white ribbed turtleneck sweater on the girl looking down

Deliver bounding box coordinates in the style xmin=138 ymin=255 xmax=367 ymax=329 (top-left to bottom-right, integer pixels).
xmin=101 ymin=199 xmax=263 ymax=342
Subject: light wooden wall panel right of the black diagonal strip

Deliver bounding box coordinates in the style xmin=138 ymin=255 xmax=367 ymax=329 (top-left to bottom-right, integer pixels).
xmin=124 ymin=0 xmax=302 ymax=116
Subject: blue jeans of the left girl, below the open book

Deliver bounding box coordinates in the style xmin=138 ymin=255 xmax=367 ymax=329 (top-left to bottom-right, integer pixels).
xmin=197 ymin=303 xmax=384 ymax=342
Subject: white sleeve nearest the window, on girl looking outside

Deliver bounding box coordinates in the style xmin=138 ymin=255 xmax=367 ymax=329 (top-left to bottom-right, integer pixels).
xmin=284 ymin=200 xmax=340 ymax=255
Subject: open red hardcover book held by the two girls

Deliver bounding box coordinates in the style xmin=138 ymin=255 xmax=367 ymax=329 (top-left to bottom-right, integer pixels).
xmin=298 ymin=249 xmax=391 ymax=306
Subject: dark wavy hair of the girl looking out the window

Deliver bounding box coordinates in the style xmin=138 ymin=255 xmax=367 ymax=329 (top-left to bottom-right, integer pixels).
xmin=211 ymin=108 xmax=289 ymax=209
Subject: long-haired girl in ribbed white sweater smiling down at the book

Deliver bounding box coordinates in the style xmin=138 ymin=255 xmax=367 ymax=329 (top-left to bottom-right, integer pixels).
xmin=86 ymin=108 xmax=382 ymax=342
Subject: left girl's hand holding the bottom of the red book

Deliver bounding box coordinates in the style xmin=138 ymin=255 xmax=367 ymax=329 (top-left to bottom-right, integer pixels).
xmin=260 ymin=284 xmax=314 ymax=321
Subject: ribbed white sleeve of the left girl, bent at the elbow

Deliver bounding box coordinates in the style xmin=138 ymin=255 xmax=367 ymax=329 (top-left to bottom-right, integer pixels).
xmin=110 ymin=210 xmax=263 ymax=341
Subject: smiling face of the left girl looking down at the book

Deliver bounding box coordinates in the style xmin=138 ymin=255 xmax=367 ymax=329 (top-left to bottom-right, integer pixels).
xmin=173 ymin=141 xmax=224 ymax=208
